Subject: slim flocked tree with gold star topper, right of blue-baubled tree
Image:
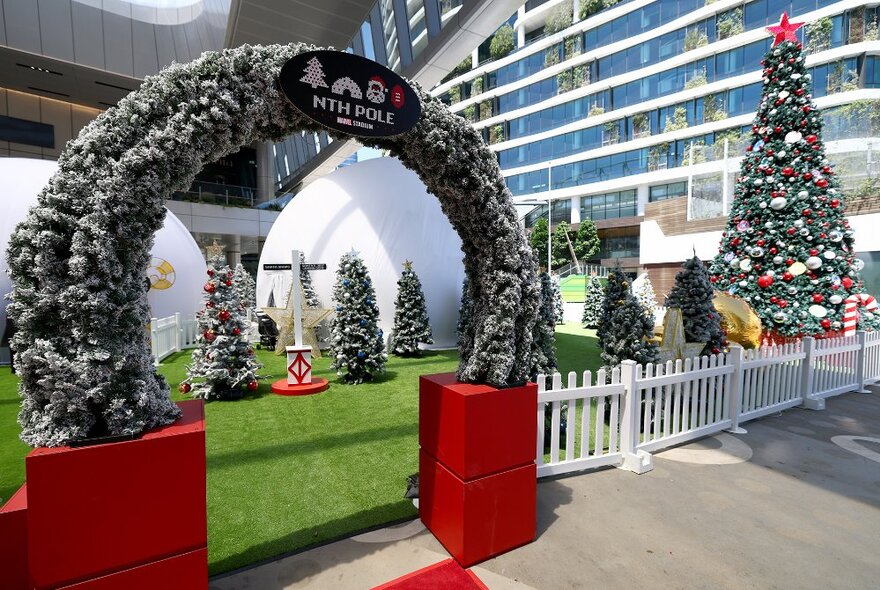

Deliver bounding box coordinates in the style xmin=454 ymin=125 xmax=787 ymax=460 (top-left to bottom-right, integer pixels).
xmin=388 ymin=260 xmax=434 ymax=356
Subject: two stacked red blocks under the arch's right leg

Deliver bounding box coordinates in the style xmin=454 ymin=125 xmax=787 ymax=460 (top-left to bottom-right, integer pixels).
xmin=419 ymin=373 xmax=538 ymax=567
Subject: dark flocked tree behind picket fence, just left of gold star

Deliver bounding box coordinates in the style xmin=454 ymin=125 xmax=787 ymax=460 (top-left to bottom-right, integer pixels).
xmin=596 ymin=266 xmax=658 ymax=368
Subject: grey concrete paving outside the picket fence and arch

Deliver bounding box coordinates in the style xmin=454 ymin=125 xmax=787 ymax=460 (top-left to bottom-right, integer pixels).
xmin=210 ymin=388 xmax=880 ymax=590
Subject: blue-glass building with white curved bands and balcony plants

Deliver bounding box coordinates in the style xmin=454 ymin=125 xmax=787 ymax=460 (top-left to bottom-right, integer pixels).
xmin=434 ymin=0 xmax=880 ymax=270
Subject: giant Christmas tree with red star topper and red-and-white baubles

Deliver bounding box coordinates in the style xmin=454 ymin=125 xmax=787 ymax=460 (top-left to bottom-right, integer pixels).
xmin=710 ymin=14 xmax=877 ymax=337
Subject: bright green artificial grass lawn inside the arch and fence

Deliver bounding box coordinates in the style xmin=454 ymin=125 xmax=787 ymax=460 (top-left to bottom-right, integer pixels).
xmin=0 ymin=325 xmax=599 ymax=574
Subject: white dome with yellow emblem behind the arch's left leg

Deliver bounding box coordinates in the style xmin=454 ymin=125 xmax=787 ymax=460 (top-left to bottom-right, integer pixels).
xmin=0 ymin=158 xmax=207 ymax=342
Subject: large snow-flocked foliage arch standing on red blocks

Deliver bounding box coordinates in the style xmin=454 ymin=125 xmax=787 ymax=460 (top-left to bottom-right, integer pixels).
xmin=7 ymin=44 xmax=539 ymax=446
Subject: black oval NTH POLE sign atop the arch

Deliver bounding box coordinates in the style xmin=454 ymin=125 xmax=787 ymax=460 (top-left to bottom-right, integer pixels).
xmin=278 ymin=51 xmax=422 ymax=137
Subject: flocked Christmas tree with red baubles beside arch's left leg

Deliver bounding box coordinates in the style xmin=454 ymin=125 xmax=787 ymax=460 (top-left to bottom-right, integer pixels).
xmin=180 ymin=256 xmax=261 ymax=399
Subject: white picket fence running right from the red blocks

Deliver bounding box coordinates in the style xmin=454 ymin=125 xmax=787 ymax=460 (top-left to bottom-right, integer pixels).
xmin=536 ymin=332 xmax=880 ymax=477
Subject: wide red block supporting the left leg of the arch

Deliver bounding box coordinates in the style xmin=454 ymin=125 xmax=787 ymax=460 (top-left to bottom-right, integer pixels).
xmin=25 ymin=400 xmax=208 ymax=589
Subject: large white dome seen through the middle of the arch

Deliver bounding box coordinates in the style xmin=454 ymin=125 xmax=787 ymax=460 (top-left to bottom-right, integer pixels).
xmin=257 ymin=158 xmax=464 ymax=348
